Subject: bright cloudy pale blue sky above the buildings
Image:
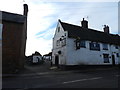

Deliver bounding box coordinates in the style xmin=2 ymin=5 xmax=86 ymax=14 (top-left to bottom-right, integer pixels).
xmin=0 ymin=0 xmax=119 ymax=56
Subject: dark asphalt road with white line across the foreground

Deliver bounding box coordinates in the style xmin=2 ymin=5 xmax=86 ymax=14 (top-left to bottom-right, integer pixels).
xmin=3 ymin=68 xmax=120 ymax=90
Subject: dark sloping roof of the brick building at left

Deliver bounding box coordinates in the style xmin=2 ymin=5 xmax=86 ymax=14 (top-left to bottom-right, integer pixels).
xmin=2 ymin=11 xmax=26 ymax=23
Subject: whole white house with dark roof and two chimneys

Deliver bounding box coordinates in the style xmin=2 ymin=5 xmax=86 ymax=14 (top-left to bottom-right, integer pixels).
xmin=52 ymin=18 xmax=120 ymax=66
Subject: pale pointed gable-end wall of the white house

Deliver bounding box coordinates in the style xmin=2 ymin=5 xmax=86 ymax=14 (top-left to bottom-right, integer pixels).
xmin=52 ymin=22 xmax=67 ymax=65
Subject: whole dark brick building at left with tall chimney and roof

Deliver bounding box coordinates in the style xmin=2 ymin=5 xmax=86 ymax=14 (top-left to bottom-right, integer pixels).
xmin=1 ymin=4 xmax=28 ymax=74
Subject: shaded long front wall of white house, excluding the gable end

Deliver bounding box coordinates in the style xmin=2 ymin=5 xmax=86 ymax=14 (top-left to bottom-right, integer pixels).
xmin=66 ymin=38 xmax=119 ymax=65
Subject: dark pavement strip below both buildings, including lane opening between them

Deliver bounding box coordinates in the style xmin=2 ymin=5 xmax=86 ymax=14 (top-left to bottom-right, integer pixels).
xmin=2 ymin=61 xmax=118 ymax=78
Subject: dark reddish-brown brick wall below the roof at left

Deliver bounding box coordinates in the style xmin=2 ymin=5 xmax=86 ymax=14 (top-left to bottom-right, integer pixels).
xmin=2 ymin=21 xmax=25 ymax=73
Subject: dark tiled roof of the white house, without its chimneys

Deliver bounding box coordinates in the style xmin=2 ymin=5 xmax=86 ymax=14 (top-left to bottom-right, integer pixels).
xmin=60 ymin=21 xmax=120 ymax=45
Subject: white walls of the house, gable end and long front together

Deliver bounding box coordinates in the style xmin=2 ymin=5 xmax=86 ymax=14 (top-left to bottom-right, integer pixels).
xmin=52 ymin=22 xmax=120 ymax=65
